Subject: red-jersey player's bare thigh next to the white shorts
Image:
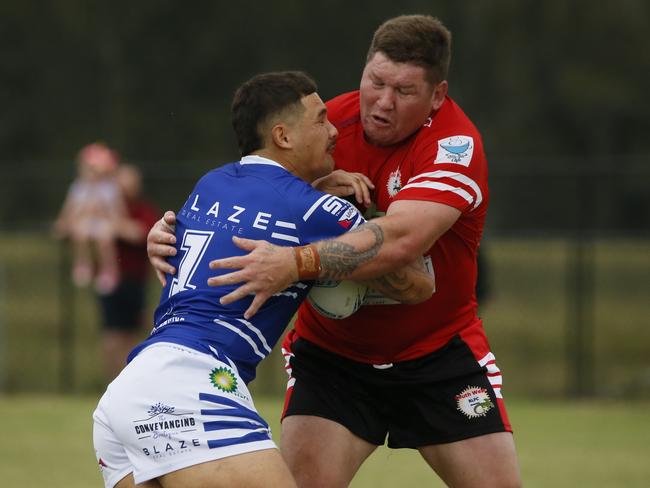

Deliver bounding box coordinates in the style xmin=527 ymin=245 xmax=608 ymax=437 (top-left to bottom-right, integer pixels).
xmin=282 ymin=415 xmax=377 ymax=488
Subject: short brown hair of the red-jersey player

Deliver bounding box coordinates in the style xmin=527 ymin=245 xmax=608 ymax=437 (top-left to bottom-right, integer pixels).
xmin=366 ymin=15 xmax=451 ymax=83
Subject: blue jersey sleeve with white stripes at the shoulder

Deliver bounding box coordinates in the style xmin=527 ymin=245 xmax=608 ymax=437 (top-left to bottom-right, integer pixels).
xmin=296 ymin=189 xmax=365 ymax=244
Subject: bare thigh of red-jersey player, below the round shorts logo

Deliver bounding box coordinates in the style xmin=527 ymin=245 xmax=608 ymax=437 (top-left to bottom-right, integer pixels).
xmin=418 ymin=432 xmax=521 ymax=488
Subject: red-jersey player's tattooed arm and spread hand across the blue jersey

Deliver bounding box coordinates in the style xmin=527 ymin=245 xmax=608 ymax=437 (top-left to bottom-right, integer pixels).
xmin=208 ymin=200 xmax=460 ymax=318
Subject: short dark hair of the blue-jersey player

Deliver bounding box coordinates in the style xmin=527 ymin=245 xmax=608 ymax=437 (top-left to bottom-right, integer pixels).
xmin=231 ymin=71 xmax=317 ymax=156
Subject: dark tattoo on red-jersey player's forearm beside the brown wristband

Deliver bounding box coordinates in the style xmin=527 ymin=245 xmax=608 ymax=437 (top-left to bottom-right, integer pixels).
xmin=319 ymin=222 xmax=384 ymax=279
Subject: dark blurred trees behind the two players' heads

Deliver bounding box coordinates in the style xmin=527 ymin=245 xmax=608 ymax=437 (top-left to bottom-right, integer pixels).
xmin=0 ymin=0 xmax=650 ymax=230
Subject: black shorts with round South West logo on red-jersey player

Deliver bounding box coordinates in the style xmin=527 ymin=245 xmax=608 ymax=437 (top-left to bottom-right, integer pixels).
xmin=283 ymin=331 xmax=511 ymax=448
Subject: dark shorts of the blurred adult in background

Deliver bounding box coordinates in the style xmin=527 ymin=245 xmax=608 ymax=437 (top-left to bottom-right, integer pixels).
xmin=98 ymin=278 xmax=146 ymax=332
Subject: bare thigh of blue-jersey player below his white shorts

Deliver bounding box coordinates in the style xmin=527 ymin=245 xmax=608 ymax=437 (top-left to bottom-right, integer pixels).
xmin=157 ymin=449 xmax=296 ymax=488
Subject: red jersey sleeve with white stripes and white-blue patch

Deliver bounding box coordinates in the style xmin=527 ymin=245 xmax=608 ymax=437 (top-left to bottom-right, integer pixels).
xmin=395 ymin=132 xmax=487 ymax=213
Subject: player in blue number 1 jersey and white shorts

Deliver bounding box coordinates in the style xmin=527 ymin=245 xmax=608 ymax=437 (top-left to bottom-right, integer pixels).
xmin=93 ymin=72 xmax=433 ymax=488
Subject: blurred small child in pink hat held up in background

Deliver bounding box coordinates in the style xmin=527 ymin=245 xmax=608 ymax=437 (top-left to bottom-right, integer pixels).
xmin=54 ymin=143 xmax=126 ymax=293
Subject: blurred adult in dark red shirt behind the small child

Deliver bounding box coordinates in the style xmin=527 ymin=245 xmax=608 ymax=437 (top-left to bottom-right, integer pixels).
xmin=98 ymin=164 xmax=159 ymax=381
